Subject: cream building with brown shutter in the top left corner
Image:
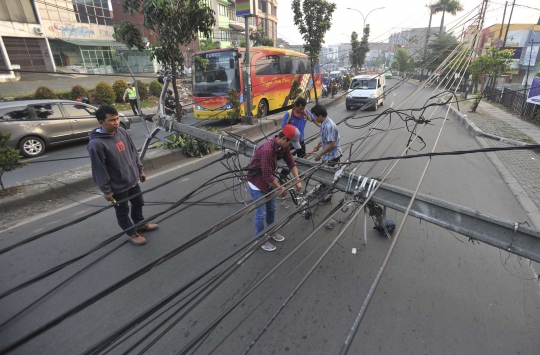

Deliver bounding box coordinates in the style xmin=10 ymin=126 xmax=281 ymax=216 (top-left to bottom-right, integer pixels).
xmin=0 ymin=0 xmax=56 ymax=81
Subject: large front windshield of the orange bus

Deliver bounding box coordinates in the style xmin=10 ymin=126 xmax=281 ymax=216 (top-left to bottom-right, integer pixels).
xmin=193 ymin=51 xmax=240 ymax=97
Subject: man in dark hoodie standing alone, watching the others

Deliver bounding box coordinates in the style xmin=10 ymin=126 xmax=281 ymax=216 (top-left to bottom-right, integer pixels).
xmin=88 ymin=106 xmax=158 ymax=245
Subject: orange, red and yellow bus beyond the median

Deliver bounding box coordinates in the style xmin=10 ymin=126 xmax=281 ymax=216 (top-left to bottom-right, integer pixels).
xmin=192 ymin=47 xmax=322 ymax=120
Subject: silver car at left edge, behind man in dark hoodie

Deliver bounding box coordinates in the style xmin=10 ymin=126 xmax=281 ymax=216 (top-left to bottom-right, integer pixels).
xmin=0 ymin=100 xmax=131 ymax=157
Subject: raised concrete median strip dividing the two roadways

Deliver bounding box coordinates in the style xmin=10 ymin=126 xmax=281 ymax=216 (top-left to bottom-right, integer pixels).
xmin=0 ymin=95 xmax=345 ymax=213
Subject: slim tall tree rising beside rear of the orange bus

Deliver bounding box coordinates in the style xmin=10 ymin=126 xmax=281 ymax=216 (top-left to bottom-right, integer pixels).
xmin=291 ymin=0 xmax=336 ymax=103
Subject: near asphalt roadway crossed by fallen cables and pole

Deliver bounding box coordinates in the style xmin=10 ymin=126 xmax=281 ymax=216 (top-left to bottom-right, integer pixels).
xmin=0 ymin=80 xmax=540 ymax=355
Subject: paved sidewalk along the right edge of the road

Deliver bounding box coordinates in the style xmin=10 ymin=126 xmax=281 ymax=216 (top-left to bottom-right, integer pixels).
xmin=460 ymin=101 xmax=540 ymax=228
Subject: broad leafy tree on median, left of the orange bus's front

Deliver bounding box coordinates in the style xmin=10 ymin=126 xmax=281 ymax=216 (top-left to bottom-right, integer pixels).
xmin=115 ymin=0 xmax=216 ymax=123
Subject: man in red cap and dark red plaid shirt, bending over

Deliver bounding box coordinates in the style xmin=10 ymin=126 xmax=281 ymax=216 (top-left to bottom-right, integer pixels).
xmin=248 ymin=124 xmax=302 ymax=251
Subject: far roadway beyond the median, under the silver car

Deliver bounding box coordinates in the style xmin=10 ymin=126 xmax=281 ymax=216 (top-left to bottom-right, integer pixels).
xmin=2 ymin=113 xmax=222 ymax=187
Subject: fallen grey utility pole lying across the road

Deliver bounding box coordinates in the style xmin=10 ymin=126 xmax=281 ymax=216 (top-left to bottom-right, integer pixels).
xmin=164 ymin=121 xmax=540 ymax=262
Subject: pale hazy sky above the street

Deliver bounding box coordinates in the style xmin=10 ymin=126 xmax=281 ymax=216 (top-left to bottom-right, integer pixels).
xmin=277 ymin=0 xmax=540 ymax=45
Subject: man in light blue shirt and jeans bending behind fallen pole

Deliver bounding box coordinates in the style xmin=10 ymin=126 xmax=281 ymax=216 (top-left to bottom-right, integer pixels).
xmin=311 ymin=105 xmax=342 ymax=203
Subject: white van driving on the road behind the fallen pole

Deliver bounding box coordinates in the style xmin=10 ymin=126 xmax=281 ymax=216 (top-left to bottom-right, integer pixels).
xmin=345 ymin=74 xmax=386 ymax=111
